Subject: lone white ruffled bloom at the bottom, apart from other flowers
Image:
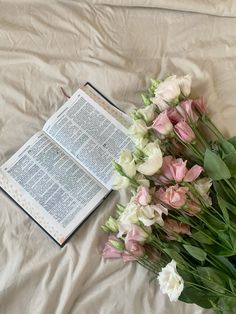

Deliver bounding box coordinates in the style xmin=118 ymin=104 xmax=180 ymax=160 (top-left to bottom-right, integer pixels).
xmin=157 ymin=260 xmax=184 ymax=302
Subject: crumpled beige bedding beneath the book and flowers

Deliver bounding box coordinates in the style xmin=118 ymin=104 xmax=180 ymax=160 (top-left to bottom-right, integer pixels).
xmin=0 ymin=0 xmax=236 ymax=314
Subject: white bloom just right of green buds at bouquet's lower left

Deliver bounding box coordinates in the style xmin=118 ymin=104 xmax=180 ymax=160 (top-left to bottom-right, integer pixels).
xmin=117 ymin=202 xmax=139 ymax=238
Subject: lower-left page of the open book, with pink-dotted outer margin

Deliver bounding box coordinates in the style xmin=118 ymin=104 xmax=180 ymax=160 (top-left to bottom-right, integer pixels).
xmin=0 ymin=132 xmax=108 ymax=243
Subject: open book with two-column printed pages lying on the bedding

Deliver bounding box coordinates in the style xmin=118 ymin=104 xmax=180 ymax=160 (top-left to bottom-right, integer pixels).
xmin=0 ymin=83 xmax=132 ymax=246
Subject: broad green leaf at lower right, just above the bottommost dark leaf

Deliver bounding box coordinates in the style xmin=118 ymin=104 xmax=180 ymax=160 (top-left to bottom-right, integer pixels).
xmin=197 ymin=267 xmax=228 ymax=293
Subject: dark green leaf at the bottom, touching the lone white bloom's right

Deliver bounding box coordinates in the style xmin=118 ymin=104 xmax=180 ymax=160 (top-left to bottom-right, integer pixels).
xmin=179 ymin=286 xmax=218 ymax=309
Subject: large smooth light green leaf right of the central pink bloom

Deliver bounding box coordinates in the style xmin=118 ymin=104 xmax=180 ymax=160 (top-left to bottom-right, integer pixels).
xmin=204 ymin=149 xmax=231 ymax=181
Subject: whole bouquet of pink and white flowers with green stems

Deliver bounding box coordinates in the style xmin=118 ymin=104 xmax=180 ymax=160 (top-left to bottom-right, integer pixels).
xmin=102 ymin=75 xmax=236 ymax=314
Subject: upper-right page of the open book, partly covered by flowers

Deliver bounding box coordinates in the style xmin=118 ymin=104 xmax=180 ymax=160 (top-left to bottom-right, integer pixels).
xmin=43 ymin=89 xmax=133 ymax=189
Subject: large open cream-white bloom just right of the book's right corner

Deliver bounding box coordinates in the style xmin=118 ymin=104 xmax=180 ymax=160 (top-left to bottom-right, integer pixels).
xmin=137 ymin=141 xmax=162 ymax=176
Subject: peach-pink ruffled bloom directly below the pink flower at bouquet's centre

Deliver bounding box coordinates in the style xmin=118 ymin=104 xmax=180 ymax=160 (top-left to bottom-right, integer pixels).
xmin=156 ymin=185 xmax=188 ymax=208
